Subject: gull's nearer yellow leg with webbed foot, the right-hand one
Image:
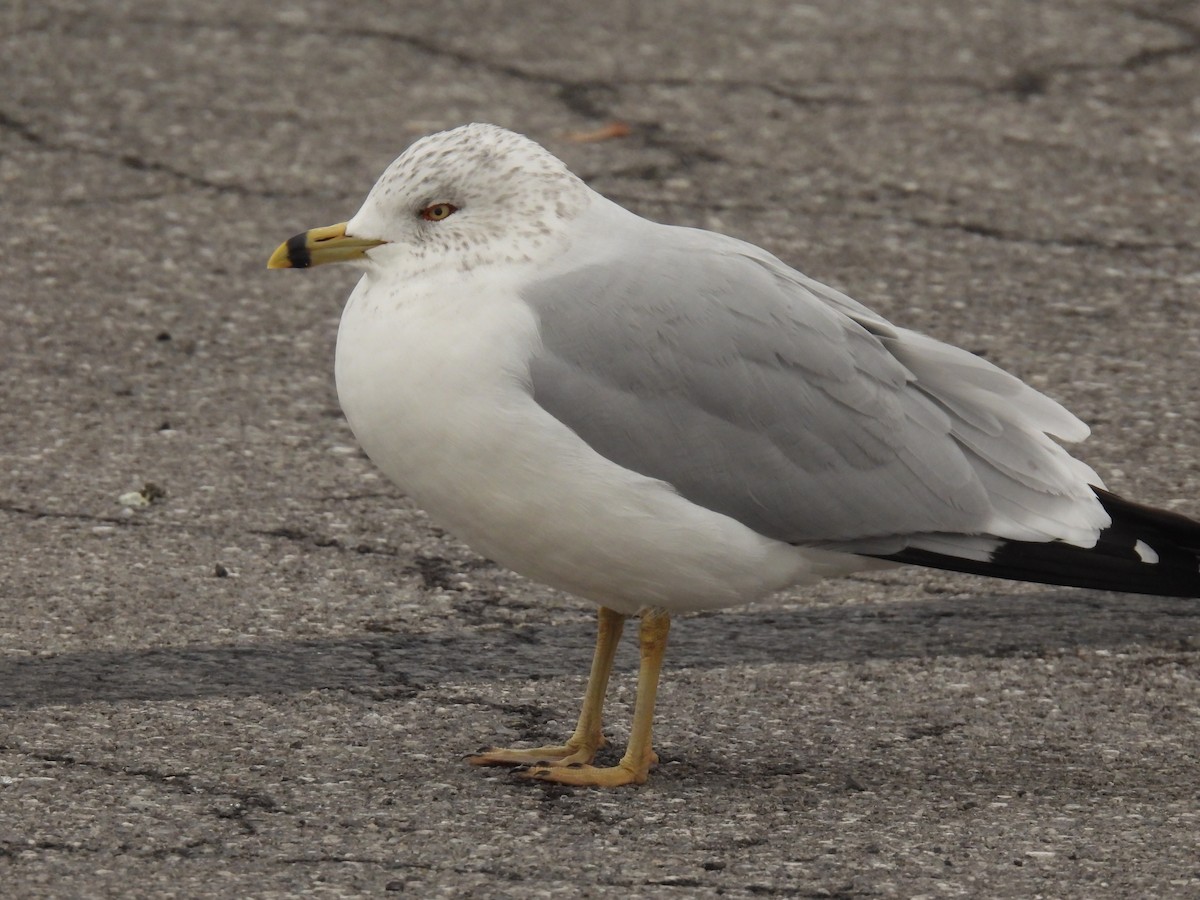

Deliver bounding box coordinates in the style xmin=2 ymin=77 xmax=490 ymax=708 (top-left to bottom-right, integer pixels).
xmin=528 ymin=610 xmax=671 ymax=787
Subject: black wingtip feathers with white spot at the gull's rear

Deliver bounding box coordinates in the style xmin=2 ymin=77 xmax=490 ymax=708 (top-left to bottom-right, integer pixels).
xmin=878 ymin=487 xmax=1200 ymax=596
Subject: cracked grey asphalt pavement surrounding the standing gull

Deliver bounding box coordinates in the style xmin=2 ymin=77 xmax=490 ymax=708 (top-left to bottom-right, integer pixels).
xmin=0 ymin=0 xmax=1200 ymax=898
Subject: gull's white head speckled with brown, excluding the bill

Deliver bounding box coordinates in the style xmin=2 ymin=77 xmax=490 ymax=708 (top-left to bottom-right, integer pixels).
xmin=346 ymin=124 xmax=593 ymax=272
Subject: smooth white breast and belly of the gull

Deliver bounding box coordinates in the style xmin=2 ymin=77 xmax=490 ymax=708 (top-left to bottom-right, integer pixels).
xmin=336 ymin=271 xmax=870 ymax=613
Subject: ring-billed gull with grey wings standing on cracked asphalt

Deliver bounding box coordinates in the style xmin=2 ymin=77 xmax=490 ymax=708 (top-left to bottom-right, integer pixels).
xmin=269 ymin=125 xmax=1200 ymax=786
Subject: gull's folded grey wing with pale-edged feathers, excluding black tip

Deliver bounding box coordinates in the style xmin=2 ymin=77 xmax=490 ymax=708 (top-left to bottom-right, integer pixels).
xmin=524 ymin=226 xmax=1098 ymax=552
